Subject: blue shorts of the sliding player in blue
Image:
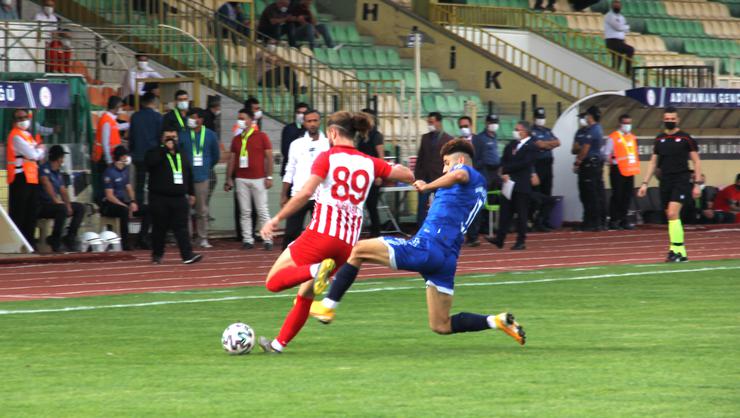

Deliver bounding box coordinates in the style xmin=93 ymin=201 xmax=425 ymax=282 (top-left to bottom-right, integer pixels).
xmin=380 ymin=236 xmax=457 ymax=295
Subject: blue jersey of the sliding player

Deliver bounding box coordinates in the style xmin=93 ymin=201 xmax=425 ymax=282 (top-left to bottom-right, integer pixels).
xmin=419 ymin=164 xmax=486 ymax=250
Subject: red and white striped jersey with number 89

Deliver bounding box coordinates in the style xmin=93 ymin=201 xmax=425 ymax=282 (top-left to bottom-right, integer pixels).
xmin=308 ymin=146 xmax=391 ymax=245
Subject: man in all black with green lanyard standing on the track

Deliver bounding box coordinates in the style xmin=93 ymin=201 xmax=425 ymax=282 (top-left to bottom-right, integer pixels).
xmin=144 ymin=130 xmax=203 ymax=264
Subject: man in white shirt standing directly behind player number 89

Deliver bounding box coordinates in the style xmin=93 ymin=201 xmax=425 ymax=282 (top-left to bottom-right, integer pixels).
xmin=280 ymin=110 xmax=331 ymax=250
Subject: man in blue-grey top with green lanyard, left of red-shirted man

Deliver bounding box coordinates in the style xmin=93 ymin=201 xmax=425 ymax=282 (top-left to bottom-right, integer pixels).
xmin=178 ymin=107 xmax=221 ymax=248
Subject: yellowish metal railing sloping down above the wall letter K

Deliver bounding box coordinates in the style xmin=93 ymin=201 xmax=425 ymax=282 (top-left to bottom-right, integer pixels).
xmin=429 ymin=2 xmax=634 ymax=76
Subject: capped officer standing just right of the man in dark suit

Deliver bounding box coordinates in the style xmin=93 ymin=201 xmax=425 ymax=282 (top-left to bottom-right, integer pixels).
xmin=532 ymin=107 xmax=560 ymax=232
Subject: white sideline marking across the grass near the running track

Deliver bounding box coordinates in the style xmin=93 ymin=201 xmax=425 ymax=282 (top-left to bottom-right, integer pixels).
xmin=0 ymin=266 xmax=740 ymax=315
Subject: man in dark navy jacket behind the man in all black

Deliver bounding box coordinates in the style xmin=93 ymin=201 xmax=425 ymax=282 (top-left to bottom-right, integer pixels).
xmin=128 ymin=93 xmax=162 ymax=203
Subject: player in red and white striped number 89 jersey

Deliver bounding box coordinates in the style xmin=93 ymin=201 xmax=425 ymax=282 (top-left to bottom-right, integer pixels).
xmin=260 ymin=112 xmax=414 ymax=352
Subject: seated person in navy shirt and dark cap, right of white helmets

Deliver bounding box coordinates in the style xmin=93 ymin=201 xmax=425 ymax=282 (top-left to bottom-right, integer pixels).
xmin=100 ymin=145 xmax=150 ymax=251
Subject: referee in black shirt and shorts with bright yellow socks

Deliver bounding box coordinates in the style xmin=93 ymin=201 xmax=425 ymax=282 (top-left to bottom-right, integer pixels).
xmin=637 ymin=107 xmax=702 ymax=263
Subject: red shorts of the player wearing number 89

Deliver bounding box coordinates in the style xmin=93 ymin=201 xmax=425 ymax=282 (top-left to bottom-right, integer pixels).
xmin=288 ymin=230 xmax=352 ymax=268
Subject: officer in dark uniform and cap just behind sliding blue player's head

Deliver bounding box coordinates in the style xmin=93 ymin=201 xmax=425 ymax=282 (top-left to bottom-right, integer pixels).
xmin=467 ymin=114 xmax=501 ymax=247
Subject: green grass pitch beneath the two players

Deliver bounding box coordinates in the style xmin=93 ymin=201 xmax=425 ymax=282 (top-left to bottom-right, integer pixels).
xmin=0 ymin=260 xmax=740 ymax=417
